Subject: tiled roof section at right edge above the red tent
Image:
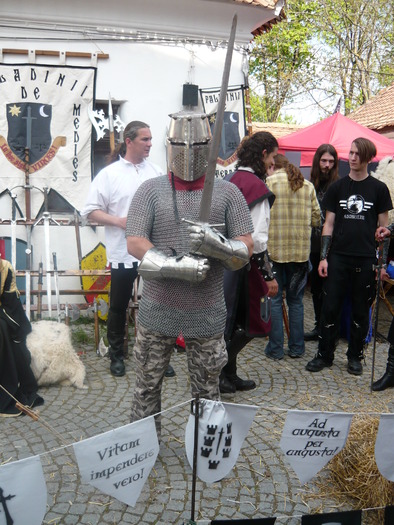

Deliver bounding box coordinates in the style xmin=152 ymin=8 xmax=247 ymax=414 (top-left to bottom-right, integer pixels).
xmin=347 ymin=84 xmax=394 ymax=130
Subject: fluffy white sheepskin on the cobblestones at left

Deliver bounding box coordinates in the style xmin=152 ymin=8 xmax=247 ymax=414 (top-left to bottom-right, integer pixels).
xmin=27 ymin=321 xmax=86 ymax=388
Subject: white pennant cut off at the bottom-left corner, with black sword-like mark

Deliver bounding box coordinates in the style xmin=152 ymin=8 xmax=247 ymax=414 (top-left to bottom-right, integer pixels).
xmin=0 ymin=456 xmax=47 ymax=525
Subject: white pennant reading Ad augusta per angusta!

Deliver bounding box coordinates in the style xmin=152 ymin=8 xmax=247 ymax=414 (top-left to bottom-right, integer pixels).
xmin=280 ymin=410 xmax=353 ymax=483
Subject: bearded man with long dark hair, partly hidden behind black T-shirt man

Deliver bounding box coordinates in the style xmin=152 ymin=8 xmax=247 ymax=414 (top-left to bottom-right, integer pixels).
xmin=304 ymin=144 xmax=339 ymax=341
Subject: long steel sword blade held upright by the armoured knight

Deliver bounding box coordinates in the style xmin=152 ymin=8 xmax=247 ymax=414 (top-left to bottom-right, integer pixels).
xmin=199 ymin=14 xmax=238 ymax=222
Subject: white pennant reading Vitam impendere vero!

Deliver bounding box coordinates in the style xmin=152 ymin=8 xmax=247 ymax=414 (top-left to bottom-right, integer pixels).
xmin=73 ymin=416 xmax=159 ymax=507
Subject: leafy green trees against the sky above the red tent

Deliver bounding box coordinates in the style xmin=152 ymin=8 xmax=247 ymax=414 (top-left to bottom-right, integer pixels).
xmin=249 ymin=0 xmax=394 ymax=121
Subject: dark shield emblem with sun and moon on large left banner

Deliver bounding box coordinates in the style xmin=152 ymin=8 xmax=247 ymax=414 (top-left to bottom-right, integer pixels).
xmin=7 ymin=102 xmax=52 ymax=164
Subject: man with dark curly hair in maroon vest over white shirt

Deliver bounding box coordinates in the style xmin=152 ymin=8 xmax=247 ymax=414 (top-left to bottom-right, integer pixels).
xmin=219 ymin=131 xmax=278 ymax=394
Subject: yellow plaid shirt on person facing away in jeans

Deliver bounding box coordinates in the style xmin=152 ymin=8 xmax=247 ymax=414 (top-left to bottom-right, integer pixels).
xmin=266 ymin=170 xmax=320 ymax=263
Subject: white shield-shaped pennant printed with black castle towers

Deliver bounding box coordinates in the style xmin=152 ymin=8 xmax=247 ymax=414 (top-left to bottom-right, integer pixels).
xmin=185 ymin=399 xmax=258 ymax=483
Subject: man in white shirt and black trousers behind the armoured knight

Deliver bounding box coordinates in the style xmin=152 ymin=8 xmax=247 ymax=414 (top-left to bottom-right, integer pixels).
xmin=82 ymin=120 xmax=162 ymax=377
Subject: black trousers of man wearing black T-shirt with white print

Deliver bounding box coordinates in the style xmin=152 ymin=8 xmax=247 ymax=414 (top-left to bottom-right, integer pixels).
xmin=319 ymin=253 xmax=375 ymax=361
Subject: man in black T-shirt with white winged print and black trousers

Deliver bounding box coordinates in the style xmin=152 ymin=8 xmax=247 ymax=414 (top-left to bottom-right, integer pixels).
xmin=306 ymin=137 xmax=393 ymax=375
